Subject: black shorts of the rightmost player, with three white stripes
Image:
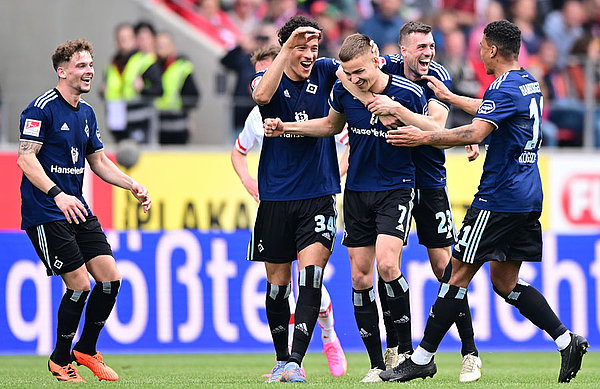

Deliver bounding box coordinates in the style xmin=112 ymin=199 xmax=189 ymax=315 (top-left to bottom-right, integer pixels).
xmin=452 ymin=207 xmax=542 ymax=263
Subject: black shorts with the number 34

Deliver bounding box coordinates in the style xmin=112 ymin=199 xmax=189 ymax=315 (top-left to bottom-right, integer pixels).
xmin=246 ymin=195 xmax=337 ymax=263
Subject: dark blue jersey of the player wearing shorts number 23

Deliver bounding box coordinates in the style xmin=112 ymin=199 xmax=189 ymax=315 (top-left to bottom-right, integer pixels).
xmin=379 ymin=54 xmax=452 ymax=189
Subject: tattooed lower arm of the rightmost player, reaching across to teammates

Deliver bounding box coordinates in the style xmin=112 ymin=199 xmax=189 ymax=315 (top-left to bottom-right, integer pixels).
xmin=386 ymin=120 xmax=494 ymax=147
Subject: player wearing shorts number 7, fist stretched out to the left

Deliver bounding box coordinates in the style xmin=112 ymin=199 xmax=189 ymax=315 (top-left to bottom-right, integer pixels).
xmin=265 ymin=34 xmax=427 ymax=382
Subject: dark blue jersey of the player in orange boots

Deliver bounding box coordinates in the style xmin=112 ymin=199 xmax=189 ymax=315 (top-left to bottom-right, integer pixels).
xmin=20 ymin=89 xmax=104 ymax=229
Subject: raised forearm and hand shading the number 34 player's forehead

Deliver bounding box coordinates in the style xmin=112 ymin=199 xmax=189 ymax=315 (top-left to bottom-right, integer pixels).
xmin=252 ymin=27 xmax=321 ymax=105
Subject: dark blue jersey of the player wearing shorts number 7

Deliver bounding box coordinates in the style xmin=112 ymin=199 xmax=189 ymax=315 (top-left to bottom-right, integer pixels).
xmin=329 ymin=75 xmax=427 ymax=192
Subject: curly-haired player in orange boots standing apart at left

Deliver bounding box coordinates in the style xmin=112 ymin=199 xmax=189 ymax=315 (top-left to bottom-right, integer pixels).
xmin=17 ymin=39 xmax=151 ymax=382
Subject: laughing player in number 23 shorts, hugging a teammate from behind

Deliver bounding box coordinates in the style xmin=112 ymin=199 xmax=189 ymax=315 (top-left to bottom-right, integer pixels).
xmin=342 ymin=21 xmax=481 ymax=382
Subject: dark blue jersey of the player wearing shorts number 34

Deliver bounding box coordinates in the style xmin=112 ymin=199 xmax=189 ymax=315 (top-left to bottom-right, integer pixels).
xmin=252 ymin=58 xmax=340 ymax=201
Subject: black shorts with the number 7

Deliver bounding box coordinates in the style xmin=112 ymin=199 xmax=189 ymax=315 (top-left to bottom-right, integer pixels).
xmin=342 ymin=188 xmax=415 ymax=247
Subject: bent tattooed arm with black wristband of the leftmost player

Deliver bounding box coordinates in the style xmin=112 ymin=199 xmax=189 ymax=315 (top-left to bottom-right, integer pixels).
xmin=17 ymin=141 xmax=87 ymax=224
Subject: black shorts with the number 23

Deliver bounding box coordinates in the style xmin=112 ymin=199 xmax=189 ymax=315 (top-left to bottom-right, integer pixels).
xmin=412 ymin=188 xmax=456 ymax=248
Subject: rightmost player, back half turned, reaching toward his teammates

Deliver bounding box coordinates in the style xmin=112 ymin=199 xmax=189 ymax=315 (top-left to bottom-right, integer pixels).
xmin=381 ymin=20 xmax=588 ymax=382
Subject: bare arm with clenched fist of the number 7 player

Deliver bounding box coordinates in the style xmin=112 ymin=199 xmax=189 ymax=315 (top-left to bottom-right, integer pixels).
xmin=264 ymin=109 xmax=346 ymax=138
